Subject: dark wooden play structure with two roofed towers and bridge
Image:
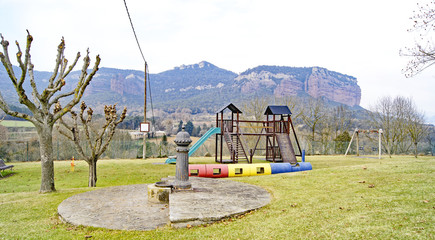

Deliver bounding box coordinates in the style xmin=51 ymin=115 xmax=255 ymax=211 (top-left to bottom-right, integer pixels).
xmin=215 ymin=103 xmax=301 ymax=164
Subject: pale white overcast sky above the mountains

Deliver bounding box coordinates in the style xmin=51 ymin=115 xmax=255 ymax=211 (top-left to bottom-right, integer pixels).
xmin=0 ymin=0 xmax=435 ymax=123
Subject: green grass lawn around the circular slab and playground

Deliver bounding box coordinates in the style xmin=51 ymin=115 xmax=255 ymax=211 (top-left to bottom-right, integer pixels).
xmin=0 ymin=156 xmax=435 ymax=239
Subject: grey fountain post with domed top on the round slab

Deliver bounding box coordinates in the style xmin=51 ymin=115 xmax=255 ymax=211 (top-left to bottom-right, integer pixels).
xmin=172 ymin=127 xmax=192 ymax=189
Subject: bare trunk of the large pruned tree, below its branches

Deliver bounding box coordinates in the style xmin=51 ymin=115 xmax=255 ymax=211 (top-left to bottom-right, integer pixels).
xmin=36 ymin=124 xmax=56 ymax=193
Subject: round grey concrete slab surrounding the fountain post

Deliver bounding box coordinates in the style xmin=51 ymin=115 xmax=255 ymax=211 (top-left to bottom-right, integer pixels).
xmin=58 ymin=178 xmax=270 ymax=230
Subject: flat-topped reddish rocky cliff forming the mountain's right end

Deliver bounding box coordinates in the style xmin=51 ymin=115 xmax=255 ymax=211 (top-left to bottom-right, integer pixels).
xmin=233 ymin=66 xmax=361 ymax=106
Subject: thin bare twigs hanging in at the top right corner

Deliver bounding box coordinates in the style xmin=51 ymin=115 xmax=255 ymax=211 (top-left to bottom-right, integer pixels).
xmin=400 ymin=1 xmax=435 ymax=77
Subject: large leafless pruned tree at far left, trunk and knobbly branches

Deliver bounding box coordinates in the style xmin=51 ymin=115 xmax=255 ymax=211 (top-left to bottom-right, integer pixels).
xmin=0 ymin=31 xmax=100 ymax=193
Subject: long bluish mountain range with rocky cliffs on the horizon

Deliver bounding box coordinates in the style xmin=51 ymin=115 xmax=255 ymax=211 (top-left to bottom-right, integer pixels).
xmin=0 ymin=61 xmax=361 ymax=114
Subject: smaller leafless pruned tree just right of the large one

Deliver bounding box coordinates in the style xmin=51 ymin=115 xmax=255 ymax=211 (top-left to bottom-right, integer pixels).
xmin=55 ymin=102 xmax=127 ymax=187
